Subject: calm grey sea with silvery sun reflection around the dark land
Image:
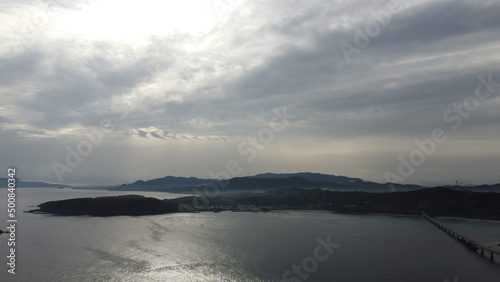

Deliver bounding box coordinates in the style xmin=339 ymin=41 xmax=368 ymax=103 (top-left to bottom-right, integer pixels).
xmin=0 ymin=188 xmax=500 ymax=282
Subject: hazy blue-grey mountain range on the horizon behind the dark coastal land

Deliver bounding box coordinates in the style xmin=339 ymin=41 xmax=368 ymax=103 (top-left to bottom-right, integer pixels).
xmin=106 ymin=172 xmax=500 ymax=195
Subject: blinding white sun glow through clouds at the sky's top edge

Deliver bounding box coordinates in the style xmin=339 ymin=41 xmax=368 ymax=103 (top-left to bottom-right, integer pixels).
xmin=60 ymin=0 xmax=221 ymax=43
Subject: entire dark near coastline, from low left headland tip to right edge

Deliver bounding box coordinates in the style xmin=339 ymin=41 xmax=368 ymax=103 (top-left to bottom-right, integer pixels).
xmin=29 ymin=187 xmax=500 ymax=220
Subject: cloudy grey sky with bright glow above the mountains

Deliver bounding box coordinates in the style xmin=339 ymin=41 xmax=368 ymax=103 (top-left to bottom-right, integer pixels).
xmin=0 ymin=0 xmax=500 ymax=185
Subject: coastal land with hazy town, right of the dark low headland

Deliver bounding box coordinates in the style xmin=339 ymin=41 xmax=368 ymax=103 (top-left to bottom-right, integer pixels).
xmin=169 ymin=187 xmax=500 ymax=220
